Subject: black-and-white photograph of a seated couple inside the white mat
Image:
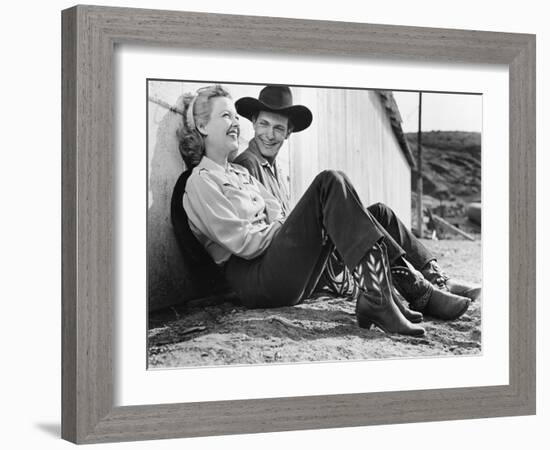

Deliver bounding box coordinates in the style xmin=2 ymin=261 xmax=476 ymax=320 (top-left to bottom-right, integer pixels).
xmin=146 ymin=79 xmax=483 ymax=369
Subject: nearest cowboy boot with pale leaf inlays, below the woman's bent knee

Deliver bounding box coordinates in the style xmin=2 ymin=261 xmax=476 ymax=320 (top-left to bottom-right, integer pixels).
xmin=354 ymin=244 xmax=425 ymax=336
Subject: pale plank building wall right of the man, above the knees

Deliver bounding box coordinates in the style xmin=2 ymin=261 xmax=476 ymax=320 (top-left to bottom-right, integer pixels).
xmin=289 ymin=88 xmax=411 ymax=225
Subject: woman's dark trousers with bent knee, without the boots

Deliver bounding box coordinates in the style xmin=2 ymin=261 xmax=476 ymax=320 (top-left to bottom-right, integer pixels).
xmin=225 ymin=171 xmax=386 ymax=308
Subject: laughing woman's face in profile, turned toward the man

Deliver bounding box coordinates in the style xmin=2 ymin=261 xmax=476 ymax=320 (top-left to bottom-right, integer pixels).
xmin=198 ymin=97 xmax=240 ymax=155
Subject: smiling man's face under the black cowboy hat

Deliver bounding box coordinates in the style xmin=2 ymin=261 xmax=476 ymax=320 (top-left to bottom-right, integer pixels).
xmin=253 ymin=111 xmax=290 ymax=159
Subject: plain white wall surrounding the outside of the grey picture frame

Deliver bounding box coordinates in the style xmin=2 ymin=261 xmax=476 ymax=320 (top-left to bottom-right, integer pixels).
xmin=0 ymin=0 xmax=550 ymax=450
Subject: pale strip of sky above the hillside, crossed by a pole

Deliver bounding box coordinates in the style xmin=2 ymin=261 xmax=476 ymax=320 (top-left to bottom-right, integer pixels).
xmin=393 ymin=91 xmax=482 ymax=133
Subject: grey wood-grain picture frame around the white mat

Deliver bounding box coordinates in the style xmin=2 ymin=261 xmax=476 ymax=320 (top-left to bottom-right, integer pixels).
xmin=62 ymin=6 xmax=536 ymax=443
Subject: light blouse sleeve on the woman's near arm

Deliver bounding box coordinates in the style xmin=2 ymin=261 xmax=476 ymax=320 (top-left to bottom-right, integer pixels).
xmin=183 ymin=172 xmax=281 ymax=259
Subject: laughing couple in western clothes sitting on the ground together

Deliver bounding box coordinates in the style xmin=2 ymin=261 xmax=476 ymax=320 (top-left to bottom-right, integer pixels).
xmin=177 ymin=85 xmax=481 ymax=336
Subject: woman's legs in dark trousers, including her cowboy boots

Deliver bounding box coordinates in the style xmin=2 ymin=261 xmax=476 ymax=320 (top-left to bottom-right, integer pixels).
xmin=225 ymin=171 xmax=468 ymax=326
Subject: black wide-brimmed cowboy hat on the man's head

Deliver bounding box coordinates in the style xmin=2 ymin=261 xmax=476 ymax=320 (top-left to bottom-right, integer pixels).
xmin=235 ymin=86 xmax=313 ymax=133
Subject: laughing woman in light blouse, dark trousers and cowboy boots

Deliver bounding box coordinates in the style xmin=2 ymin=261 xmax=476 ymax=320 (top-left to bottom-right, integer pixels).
xmin=179 ymin=85 xmax=469 ymax=336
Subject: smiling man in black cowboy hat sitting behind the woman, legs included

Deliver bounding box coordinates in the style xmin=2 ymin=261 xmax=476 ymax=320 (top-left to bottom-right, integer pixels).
xmin=234 ymin=86 xmax=481 ymax=320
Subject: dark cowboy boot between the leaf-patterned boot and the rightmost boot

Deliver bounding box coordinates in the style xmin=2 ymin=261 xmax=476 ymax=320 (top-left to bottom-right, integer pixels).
xmin=391 ymin=266 xmax=470 ymax=320
